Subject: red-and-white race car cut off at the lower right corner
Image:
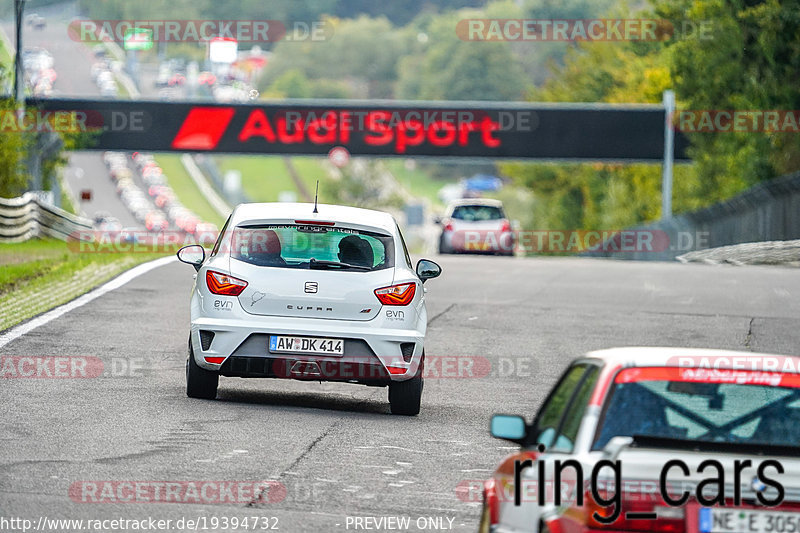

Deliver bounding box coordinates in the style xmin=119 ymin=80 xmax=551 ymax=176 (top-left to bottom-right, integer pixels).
xmin=480 ymin=348 xmax=800 ymax=533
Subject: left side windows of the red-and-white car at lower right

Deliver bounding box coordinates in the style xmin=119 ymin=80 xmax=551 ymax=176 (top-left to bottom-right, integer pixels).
xmin=528 ymin=363 xmax=588 ymax=451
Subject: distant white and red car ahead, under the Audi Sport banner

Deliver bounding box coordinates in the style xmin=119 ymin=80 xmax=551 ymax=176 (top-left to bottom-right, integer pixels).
xmin=438 ymin=198 xmax=516 ymax=255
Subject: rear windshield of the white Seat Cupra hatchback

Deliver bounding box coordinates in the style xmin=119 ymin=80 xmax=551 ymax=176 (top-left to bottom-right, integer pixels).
xmin=230 ymin=224 xmax=394 ymax=272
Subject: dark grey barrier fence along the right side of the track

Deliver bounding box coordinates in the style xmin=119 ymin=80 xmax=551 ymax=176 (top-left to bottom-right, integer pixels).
xmin=583 ymin=172 xmax=800 ymax=261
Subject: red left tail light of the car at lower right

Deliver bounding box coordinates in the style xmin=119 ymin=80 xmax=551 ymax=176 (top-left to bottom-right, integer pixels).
xmin=583 ymin=489 xmax=686 ymax=533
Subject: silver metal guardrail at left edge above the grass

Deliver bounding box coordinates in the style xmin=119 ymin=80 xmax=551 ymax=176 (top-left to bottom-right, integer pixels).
xmin=0 ymin=193 xmax=92 ymax=243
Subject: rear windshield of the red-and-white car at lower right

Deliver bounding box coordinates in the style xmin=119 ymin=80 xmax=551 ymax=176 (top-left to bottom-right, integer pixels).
xmin=593 ymin=369 xmax=800 ymax=450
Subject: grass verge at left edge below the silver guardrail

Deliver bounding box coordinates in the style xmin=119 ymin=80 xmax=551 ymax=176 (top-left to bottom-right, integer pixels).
xmin=0 ymin=239 xmax=163 ymax=331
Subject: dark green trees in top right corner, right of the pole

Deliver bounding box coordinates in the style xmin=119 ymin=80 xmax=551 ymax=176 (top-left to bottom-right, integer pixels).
xmin=653 ymin=0 xmax=800 ymax=190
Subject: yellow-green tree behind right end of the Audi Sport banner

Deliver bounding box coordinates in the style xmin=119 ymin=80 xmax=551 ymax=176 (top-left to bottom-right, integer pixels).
xmin=500 ymin=11 xmax=697 ymax=229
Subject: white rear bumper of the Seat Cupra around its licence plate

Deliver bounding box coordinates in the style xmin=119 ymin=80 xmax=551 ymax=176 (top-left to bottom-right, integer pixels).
xmin=191 ymin=317 xmax=424 ymax=385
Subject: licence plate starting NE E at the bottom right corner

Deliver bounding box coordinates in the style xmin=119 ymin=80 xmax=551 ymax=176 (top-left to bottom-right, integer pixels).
xmin=698 ymin=508 xmax=800 ymax=533
